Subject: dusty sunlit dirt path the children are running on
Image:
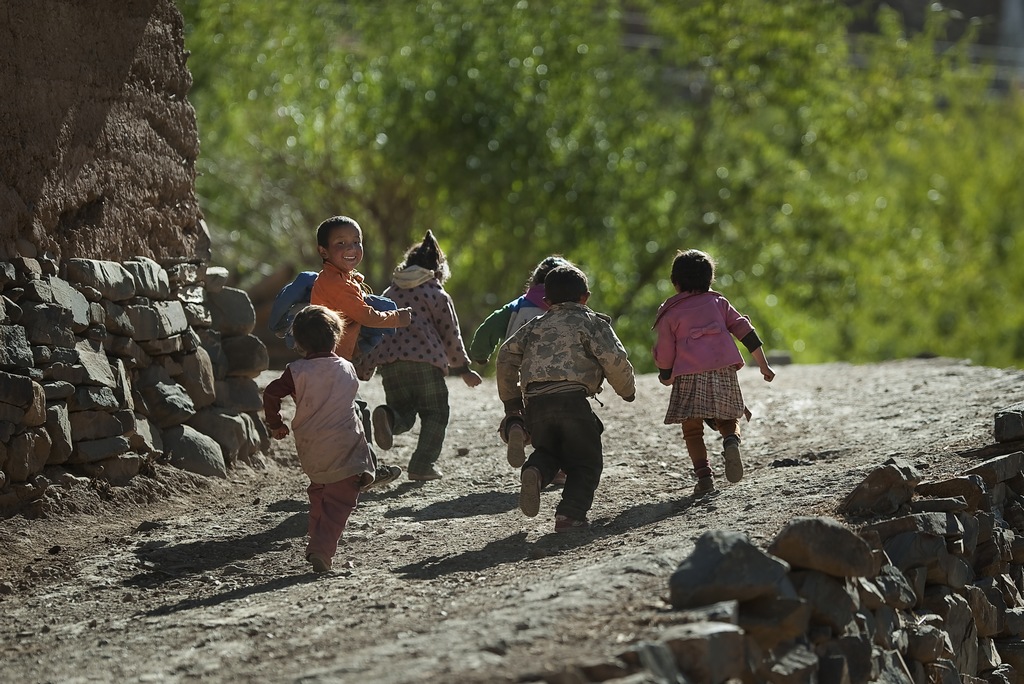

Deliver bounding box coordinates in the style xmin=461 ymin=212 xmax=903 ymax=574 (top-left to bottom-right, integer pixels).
xmin=0 ymin=358 xmax=1024 ymax=683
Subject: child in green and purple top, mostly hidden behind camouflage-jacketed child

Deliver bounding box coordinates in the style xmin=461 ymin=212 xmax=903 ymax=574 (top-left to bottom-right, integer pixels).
xmin=469 ymin=254 xmax=572 ymax=475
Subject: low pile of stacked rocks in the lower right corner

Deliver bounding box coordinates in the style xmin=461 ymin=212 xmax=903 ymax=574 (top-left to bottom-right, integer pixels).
xmin=545 ymin=452 xmax=1024 ymax=684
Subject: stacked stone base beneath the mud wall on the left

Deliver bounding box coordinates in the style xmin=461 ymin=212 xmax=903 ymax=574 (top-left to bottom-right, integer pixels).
xmin=0 ymin=257 xmax=268 ymax=510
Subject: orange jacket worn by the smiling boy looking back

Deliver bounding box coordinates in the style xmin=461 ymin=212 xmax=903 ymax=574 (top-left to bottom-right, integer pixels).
xmin=309 ymin=262 xmax=399 ymax=360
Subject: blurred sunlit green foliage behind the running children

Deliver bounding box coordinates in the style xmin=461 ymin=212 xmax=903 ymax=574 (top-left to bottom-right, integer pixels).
xmin=179 ymin=0 xmax=1024 ymax=371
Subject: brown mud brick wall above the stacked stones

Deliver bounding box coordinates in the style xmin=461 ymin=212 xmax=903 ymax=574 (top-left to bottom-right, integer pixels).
xmin=0 ymin=0 xmax=211 ymax=263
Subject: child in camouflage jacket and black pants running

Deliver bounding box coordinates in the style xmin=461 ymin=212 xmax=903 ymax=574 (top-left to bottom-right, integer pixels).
xmin=498 ymin=266 xmax=636 ymax=532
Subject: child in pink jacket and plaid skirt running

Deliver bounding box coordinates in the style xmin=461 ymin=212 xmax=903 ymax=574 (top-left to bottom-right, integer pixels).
xmin=653 ymin=250 xmax=775 ymax=497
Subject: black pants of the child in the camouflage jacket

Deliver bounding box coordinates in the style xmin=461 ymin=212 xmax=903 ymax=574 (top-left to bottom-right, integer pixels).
xmin=523 ymin=392 xmax=604 ymax=520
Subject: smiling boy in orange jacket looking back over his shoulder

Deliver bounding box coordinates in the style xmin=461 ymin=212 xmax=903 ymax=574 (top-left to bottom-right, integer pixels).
xmin=309 ymin=216 xmax=413 ymax=486
